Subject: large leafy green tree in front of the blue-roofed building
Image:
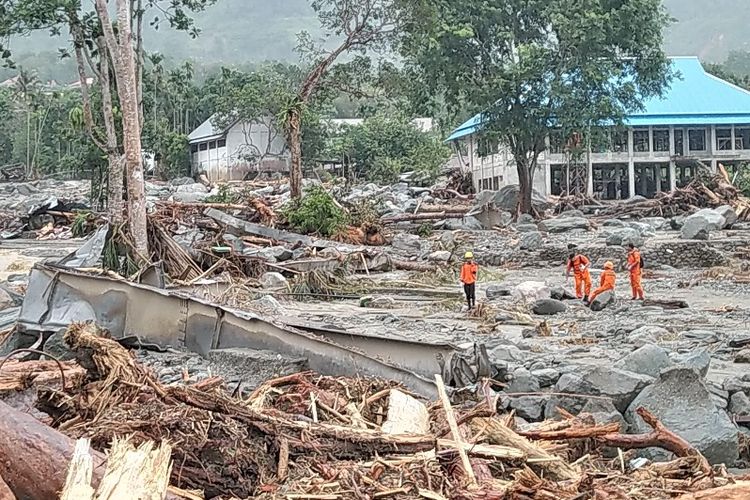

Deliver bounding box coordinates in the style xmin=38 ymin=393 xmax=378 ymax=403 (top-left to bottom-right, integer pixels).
xmin=402 ymin=0 xmax=670 ymax=213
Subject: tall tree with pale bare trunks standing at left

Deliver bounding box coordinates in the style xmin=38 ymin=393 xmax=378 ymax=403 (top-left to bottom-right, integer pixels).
xmin=0 ymin=0 xmax=216 ymax=259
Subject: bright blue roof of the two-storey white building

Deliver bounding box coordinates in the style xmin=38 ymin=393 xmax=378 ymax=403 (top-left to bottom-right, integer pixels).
xmin=447 ymin=57 xmax=750 ymax=141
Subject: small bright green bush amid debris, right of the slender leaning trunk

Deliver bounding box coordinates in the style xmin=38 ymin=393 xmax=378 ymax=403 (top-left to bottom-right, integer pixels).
xmin=283 ymin=186 xmax=348 ymax=237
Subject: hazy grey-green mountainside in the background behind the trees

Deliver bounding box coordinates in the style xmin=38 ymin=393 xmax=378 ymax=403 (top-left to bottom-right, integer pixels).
xmin=0 ymin=0 xmax=750 ymax=81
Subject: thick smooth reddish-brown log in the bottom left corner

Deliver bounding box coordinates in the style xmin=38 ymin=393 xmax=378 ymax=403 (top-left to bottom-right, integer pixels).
xmin=0 ymin=401 xmax=180 ymax=500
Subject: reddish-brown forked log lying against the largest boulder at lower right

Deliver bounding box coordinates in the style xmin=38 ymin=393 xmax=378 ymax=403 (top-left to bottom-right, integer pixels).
xmin=598 ymin=408 xmax=711 ymax=475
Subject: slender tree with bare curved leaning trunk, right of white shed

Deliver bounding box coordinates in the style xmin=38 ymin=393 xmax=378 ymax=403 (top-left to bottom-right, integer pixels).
xmin=284 ymin=0 xmax=401 ymax=198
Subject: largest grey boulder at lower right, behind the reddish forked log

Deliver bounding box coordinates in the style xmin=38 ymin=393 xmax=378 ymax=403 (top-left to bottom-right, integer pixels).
xmin=625 ymin=367 xmax=739 ymax=465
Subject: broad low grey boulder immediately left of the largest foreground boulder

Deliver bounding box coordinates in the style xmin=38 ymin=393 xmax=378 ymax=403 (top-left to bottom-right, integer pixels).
xmin=547 ymin=366 xmax=654 ymax=417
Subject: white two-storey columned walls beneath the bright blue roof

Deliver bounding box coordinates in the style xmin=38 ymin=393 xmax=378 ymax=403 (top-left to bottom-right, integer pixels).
xmin=464 ymin=124 xmax=750 ymax=197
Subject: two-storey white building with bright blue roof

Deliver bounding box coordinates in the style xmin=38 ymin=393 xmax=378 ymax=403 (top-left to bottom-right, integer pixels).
xmin=448 ymin=57 xmax=750 ymax=200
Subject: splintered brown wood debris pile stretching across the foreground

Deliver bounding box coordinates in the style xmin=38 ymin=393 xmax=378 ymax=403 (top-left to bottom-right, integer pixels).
xmin=0 ymin=324 xmax=750 ymax=500
